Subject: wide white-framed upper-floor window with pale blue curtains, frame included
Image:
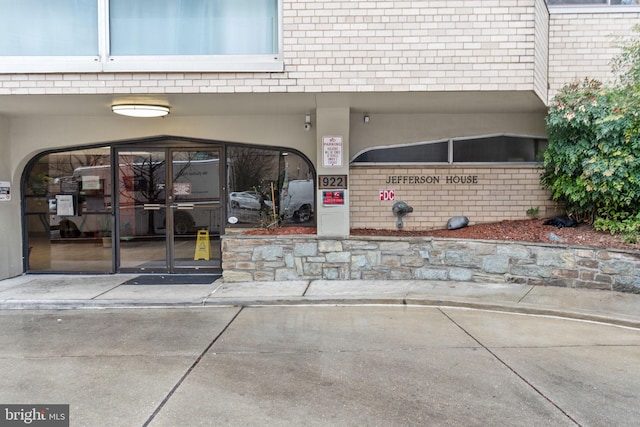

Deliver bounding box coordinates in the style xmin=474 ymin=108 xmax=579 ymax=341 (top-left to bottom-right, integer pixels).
xmin=0 ymin=0 xmax=284 ymax=73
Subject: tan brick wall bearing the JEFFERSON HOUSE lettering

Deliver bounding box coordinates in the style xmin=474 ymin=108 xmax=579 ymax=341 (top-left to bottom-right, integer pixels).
xmin=349 ymin=166 xmax=560 ymax=230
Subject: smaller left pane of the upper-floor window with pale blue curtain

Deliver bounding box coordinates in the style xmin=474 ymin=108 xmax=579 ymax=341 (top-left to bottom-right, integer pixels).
xmin=0 ymin=0 xmax=98 ymax=56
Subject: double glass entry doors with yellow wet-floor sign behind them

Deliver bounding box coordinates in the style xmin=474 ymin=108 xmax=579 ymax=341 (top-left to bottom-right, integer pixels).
xmin=117 ymin=148 xmax=221 ymax=273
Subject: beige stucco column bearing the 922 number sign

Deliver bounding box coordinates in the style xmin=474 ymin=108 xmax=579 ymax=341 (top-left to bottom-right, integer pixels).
xmin=315 ymin=107 xmax=350 ymax=237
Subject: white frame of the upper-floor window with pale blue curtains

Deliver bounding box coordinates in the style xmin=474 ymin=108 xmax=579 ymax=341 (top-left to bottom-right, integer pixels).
xmin=0 ymin=0 xmax=284 ymax=73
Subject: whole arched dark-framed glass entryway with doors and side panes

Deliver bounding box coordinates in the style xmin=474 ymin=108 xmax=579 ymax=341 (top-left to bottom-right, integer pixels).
xmin=23 ymin=138 xmax=315 ymax=274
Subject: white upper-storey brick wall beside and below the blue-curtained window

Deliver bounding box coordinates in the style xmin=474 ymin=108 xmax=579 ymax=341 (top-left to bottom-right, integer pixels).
xmin=0 ymin=0 xmax=546 ymax=95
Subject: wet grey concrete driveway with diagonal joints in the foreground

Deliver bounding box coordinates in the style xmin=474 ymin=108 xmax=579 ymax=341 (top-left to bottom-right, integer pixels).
xmin=0 ymin=305 xmax=640 ymax=426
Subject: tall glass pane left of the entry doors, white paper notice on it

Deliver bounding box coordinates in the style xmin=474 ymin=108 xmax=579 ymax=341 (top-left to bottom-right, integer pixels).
xmin=24 ymin=147 xmax=112 ymax=272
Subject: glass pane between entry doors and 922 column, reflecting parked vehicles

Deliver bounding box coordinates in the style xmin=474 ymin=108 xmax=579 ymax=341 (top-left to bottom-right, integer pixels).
xmin=227 ymin=146 xmax=315 ymax=227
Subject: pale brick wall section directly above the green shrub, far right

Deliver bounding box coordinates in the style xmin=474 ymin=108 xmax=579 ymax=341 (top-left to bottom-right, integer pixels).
xmin=549 ymin=9 xmax=640 ymax=98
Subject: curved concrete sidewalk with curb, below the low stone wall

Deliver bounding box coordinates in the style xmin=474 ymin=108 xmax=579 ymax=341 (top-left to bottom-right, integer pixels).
xmin=0 ymin=274 xmax=640 ymax=327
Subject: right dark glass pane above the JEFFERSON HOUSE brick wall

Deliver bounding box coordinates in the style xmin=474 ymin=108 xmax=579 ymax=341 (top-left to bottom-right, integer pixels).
xmin=453 ymin=136 xmax=546 ymax=163
